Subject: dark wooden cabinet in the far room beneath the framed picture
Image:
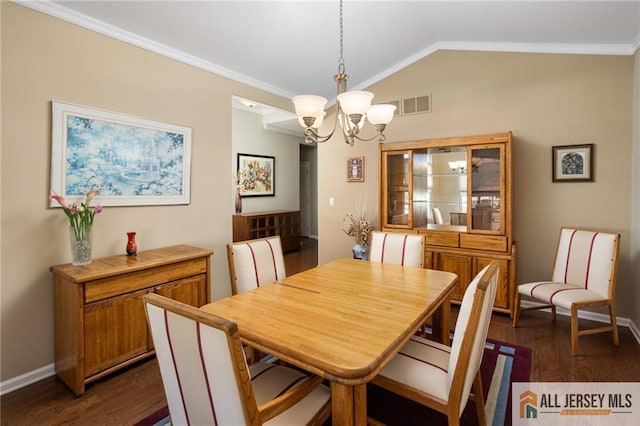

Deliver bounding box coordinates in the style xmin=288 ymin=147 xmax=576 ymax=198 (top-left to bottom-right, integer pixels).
xmin=233 ymin=210 xmax=300 ymax=252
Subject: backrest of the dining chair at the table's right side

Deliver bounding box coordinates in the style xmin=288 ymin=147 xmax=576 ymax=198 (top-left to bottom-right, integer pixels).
xmin=448 ymin=262 xmax=499 ymax=414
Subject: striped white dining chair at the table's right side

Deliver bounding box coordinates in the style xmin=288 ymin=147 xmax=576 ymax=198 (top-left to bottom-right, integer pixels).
xmin=373 ymin=262 xmax=498 ymax=425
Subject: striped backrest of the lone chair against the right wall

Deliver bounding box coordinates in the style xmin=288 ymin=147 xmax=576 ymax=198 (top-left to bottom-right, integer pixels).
xmin=552 ymin=227 xmax=620 ymax=299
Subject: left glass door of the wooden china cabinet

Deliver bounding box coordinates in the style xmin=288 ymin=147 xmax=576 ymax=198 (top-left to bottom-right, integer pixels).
xmin=382 ymin=151 xmax=412 ymax=227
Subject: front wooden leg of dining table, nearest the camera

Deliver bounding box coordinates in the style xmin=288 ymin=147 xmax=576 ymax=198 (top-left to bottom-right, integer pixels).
xmin=331 ymin=382 xmax=367 ymax=426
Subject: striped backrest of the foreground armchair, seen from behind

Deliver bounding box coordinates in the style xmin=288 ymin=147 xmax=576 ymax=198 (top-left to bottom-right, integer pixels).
xmin=143 ymin=293 xmax=259 ymax=425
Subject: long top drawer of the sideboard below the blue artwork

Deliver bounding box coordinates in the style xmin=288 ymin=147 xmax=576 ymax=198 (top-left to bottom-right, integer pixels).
xmin=84 ymin=258 xmax=207 ymax=303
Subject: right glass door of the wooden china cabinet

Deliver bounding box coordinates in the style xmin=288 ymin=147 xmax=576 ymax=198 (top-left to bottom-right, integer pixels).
xmin=468 ymin=145 xmax=505 ymax=234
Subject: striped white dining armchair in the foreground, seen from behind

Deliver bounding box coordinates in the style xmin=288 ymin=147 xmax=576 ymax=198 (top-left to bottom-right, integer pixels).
xmin=143 ymin=293 xmax=331 ymax=425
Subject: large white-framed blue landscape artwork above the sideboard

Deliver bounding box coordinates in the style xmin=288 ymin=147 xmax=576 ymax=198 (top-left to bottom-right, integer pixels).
xmin=51 ymin=101 xmax=191 ymax=207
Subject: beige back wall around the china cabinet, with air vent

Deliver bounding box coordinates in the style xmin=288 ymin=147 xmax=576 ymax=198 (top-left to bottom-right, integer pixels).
xmin=318 ymin=51 xmax=639 ymax=318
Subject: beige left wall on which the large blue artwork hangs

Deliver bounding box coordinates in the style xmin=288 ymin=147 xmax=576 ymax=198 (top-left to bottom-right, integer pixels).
xmin=0 ymin=2 xmax=291 ymax=381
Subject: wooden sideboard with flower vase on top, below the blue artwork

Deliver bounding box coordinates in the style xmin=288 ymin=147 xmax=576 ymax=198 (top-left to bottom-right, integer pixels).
xmin=50 ymin=245 xmax=213 ymax=395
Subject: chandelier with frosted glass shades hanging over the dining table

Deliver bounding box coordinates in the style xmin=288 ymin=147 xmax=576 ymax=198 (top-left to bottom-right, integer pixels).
xmin=292 ymin=0 xmax=396 ymax=146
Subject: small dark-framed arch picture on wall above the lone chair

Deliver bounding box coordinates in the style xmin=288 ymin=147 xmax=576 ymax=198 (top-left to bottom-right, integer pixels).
xmin=553 ymin=144 xmax=593 ymax=182
